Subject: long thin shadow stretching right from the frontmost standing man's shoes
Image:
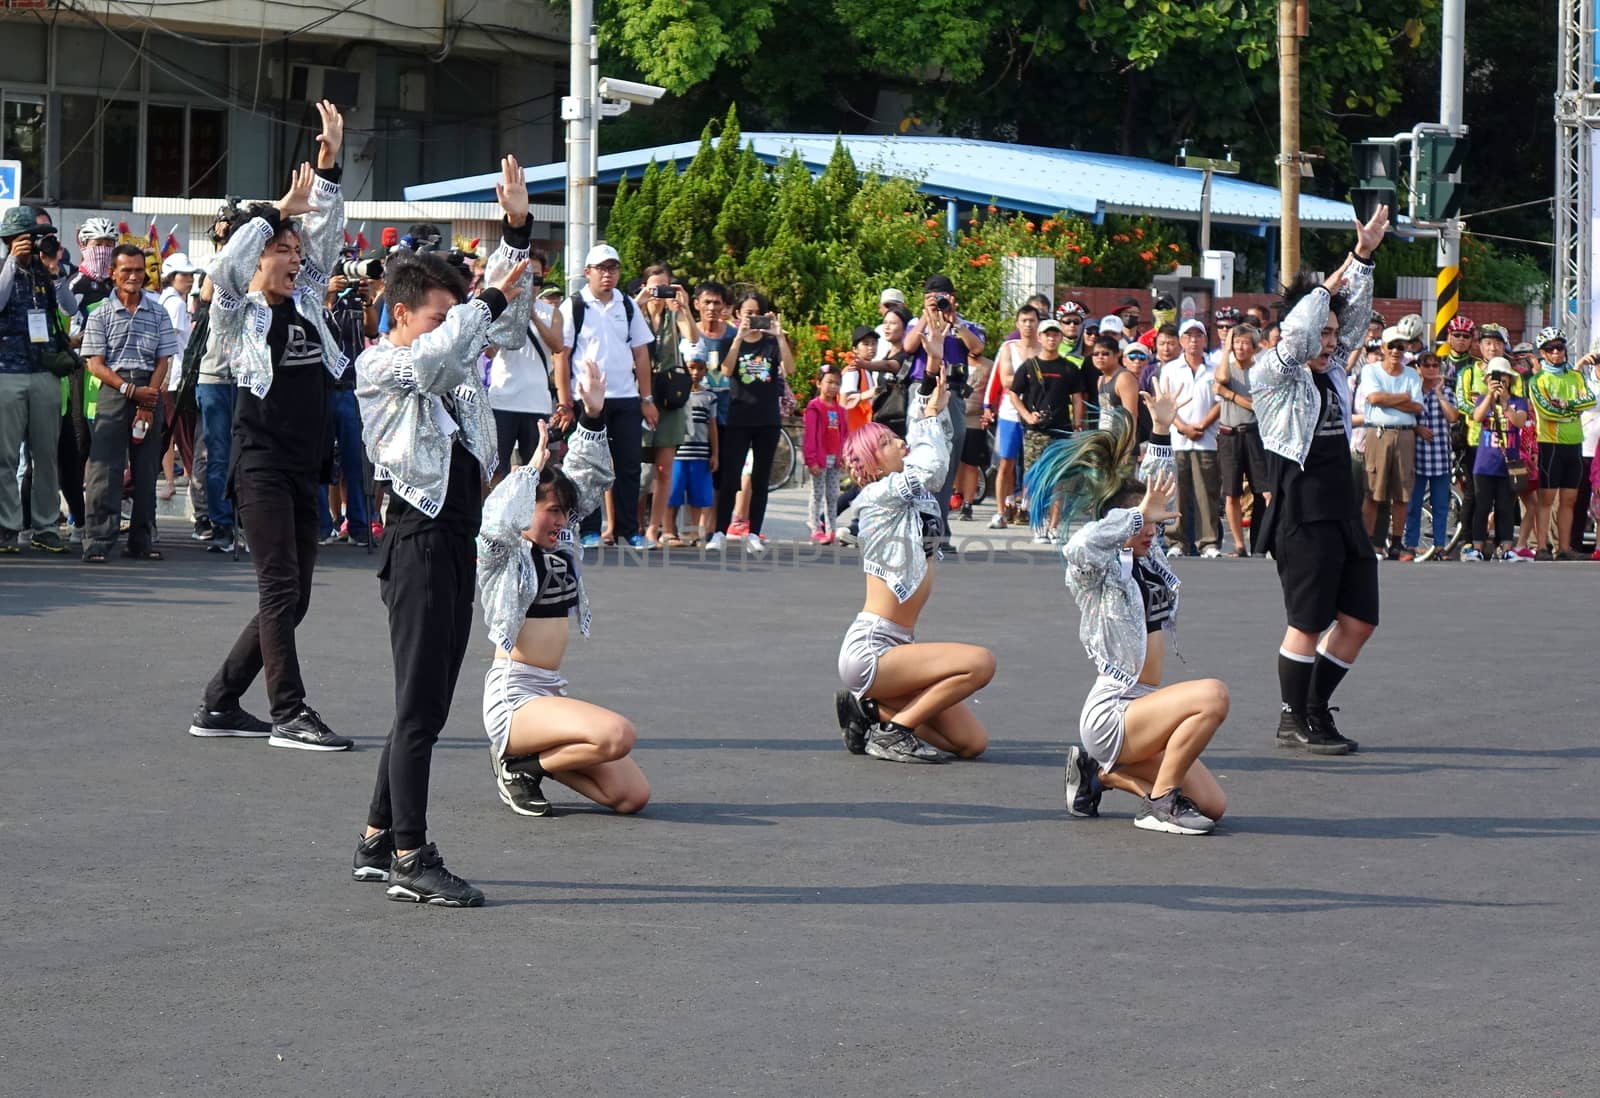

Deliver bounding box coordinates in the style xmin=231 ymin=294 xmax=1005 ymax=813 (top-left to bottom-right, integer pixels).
xmin=482 ymin=880 xmax=1539 ymax=916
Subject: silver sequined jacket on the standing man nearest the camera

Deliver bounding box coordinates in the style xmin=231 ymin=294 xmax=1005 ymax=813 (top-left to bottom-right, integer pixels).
xmin=355 ymin=232 xmax=533 ymax=519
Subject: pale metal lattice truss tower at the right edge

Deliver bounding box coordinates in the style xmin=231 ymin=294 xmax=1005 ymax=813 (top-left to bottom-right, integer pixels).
xmin=1554 ymin=0 xmax=1600 ymax=347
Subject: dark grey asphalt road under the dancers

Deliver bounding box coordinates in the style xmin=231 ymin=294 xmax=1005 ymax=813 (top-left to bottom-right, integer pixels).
xmin=0 ymin=527 xmax=1600 ymax=1098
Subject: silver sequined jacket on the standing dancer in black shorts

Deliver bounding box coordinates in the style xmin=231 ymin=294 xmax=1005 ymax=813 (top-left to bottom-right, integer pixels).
xmin=1250 ymin=259 xmax=1373 ymax=466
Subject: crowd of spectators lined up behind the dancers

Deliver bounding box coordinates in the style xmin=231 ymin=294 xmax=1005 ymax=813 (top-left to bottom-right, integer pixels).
xmin=0 ymin=206 xmax=1600 ymax=562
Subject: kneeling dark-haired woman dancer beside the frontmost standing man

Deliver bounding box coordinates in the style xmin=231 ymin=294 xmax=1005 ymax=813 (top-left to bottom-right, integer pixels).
xmin=478 ymin=362 xmax=650 ymax=816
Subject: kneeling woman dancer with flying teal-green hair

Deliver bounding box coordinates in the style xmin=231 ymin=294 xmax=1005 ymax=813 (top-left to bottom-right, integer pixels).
xmin=1027 ymin=393 xmax=1227 ymax=836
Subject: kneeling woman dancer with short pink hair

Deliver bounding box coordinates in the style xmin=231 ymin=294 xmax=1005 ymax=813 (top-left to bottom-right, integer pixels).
xmin=834 ymin=361 xmax=995 ymax=762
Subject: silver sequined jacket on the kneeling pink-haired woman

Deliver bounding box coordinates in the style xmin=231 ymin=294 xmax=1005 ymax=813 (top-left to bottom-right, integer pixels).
xmin=854 ymin=394 xmax=955 ymax=602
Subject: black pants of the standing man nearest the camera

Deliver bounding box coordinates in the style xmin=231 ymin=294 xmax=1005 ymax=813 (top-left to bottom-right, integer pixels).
xmin=366 ymin=527 xmax=475 ymax=850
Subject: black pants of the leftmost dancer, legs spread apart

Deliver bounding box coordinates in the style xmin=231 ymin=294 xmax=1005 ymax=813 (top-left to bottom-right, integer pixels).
xmin=205 ymin=469 xmax=320 ymax=723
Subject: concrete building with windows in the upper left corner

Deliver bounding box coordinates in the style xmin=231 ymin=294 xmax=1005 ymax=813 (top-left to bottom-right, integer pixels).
xmin=0 ymin=0 xmax=566 ymax=243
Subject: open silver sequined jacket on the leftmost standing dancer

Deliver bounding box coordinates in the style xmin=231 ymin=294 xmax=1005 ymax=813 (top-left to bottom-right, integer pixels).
xmin=210 ymin=173 xmax=350 ymax=399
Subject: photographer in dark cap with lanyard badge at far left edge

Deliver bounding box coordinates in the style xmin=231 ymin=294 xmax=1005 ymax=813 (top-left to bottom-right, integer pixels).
xmin=0 ymin=206 xmax=78 ymax=554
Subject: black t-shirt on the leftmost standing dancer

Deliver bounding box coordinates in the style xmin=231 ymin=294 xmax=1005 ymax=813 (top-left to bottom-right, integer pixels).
xmin=234 ymin=298 xmax=333 ymax=475
